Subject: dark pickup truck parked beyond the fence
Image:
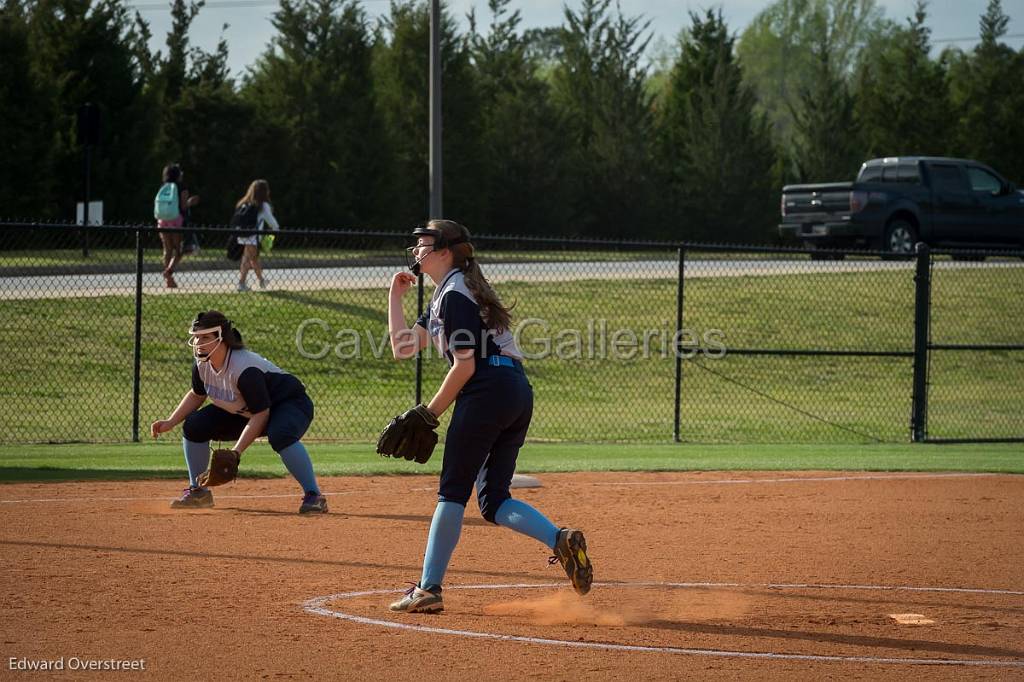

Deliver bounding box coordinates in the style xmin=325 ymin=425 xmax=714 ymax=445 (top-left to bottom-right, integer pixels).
xmin=778 ymin=157 xmax=1024 ymax=258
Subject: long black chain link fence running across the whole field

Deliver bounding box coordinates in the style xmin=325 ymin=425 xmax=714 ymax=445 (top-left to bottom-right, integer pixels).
xmin=0 ymin=222 xmax=1024 ymax=442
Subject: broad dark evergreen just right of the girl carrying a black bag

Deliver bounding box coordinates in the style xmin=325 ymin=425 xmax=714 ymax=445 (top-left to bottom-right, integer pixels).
xmin=245 ymin=0 xmax=386 ymax=229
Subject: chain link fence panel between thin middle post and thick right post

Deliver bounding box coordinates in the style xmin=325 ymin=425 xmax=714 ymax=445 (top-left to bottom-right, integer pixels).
xmin=681 ymin=244 xmax=914 ymax=442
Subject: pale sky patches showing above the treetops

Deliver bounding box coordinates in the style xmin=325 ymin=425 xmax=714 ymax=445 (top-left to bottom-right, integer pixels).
xmin=129 ymin=0 xmax=1024 ymax=76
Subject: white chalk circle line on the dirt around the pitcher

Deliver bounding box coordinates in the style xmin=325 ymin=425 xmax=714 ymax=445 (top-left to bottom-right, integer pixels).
xmin=302 ymin=582 xmax=1024 ymax=668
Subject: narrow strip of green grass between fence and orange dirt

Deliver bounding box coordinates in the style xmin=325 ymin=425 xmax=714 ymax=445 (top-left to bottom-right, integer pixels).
xmin=0 ymin=436 xmax=1024 ymax=482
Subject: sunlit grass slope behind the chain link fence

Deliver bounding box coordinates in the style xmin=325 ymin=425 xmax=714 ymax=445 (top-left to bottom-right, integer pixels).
xmin=0 ymin=260 xmax=1024 ymax=443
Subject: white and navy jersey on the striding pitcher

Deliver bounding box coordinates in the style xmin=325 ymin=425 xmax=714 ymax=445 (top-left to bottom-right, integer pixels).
xmin=416 ymin=269 xmax=522 ymax=365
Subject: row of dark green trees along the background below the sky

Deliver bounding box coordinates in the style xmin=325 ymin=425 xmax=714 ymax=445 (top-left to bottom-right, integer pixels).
xmin=0 ymin=0 xmax=1024 ymax=243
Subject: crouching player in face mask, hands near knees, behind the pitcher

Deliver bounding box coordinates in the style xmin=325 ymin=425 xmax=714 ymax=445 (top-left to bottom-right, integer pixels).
xmin=151 ymin=310 xmax=327 ymax=514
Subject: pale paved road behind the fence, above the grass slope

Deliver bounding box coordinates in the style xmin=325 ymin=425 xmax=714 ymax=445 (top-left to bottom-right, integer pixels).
xmin=0 ymin=260 xmax=1024 ymax=300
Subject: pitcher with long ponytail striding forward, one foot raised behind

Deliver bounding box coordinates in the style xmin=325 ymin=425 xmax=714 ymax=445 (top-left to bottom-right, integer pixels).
xmin=388 ymin=220 xmax=593 ymax=613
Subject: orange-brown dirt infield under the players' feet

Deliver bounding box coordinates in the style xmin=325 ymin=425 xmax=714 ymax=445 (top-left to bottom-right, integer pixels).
xmin=0 ymin=472 xmax=1024 ymax=680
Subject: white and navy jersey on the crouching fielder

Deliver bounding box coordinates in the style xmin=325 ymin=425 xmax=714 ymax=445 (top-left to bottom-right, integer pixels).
xmin=193 ymin=348 xmax=306 ymax=417
